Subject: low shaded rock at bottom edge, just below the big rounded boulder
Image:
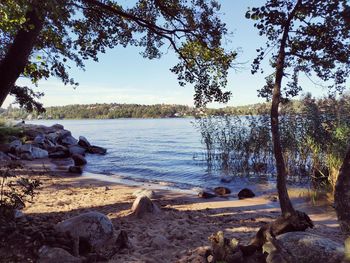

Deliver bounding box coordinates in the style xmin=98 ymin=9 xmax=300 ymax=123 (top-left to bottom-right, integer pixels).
xmin=37 ymin=246 xmax=82 ymax=263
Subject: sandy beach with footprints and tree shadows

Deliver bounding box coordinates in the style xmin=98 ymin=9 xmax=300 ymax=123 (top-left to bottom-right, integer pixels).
xmin=0 ymin=160 xmax=345 ymax=262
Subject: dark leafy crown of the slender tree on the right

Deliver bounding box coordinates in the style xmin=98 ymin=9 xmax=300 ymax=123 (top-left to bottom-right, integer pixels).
xmin=246 ymin=0 xmax=350 ymax=98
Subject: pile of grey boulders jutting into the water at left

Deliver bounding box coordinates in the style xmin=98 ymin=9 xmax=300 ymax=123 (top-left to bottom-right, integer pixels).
xmin=0 ymin=123 xmax=107 ymax=174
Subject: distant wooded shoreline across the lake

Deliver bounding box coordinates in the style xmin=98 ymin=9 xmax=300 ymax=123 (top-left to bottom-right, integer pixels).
xmin=0 ymin=94 xmax=350 ymax=119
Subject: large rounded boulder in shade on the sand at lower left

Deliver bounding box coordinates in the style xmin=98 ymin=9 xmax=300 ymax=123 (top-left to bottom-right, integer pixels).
xmin=56 ymin=211 xmax=116 ymax=255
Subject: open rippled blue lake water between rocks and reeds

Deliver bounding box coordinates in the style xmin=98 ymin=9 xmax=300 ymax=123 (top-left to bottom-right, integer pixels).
xmin=28 ymin=118 xmax=274 ymax=194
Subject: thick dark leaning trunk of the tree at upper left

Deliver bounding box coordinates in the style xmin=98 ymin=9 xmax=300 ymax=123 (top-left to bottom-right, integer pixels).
xmin=0 ymin=10 xmax=43 ymax=106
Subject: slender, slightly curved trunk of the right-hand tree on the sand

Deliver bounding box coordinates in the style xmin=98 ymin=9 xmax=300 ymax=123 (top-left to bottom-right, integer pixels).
xmin=270 ymin=0 xmax=302 ymax=216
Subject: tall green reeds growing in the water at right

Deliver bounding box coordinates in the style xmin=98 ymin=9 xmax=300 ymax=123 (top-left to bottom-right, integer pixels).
xmin=196 ymin=96 xmax=350 ymax=190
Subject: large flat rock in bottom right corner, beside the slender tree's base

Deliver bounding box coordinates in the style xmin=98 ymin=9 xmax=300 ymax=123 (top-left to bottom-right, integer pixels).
xmin=263 ymin=232 xmax=344 ymax=263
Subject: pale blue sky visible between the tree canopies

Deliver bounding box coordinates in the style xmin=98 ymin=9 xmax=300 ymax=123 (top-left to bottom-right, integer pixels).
xmin=2 ymin=0 xmax=328 ymax=107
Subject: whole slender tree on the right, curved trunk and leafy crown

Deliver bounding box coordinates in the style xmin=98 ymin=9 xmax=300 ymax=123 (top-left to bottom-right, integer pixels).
xmin=246 ymin=0 xmax=350 ymax=216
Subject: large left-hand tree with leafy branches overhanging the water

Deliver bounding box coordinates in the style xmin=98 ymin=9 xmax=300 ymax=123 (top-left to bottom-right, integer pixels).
xmin=0 ymin=0 xmax=236 ymax=110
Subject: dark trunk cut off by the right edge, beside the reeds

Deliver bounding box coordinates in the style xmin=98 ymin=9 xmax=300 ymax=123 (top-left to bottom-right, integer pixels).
xmin=334 ymin=147 xmax=350 ymax=233
